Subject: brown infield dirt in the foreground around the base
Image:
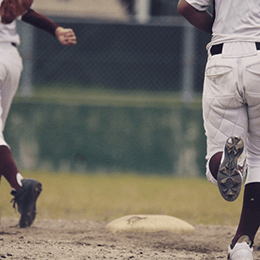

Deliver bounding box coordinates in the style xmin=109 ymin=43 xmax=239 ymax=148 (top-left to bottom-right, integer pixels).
xmin=0 ymin=218 xmax=260 ymax=260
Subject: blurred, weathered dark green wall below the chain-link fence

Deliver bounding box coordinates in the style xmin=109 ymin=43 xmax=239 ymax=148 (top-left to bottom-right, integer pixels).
xmin=5 ymin=90 xmax=205 ymax=176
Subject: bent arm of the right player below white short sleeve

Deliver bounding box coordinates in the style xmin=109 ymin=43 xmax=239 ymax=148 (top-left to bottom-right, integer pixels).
xmin=178 ymin=0 xmax=214 ymax=34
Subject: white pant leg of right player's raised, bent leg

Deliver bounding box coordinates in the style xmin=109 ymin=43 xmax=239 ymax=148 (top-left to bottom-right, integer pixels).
xmin=202 ymin=55 xmax=248 ymax=184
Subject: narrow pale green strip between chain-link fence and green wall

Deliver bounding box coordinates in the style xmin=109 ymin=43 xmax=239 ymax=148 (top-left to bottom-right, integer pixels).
xmin=15 ymin=85 xmax=201 ymax=108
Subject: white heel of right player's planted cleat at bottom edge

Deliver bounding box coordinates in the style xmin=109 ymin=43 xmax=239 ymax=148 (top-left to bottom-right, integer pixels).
xmin=228 ymin=242 xmax=254 ymax=260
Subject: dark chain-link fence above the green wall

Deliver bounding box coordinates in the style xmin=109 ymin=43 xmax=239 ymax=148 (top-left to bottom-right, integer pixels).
xmin=16 ymin=10 xmax=209 ymax=96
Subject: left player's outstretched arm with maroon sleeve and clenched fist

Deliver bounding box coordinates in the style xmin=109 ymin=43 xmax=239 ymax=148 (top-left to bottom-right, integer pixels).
xmin=22 ymin=9 xmax=77 ymax=45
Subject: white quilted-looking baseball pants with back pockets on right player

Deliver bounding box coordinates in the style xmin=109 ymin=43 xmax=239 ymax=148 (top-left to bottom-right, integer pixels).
xmin=203 ymin=42 xmax=260 ymax=184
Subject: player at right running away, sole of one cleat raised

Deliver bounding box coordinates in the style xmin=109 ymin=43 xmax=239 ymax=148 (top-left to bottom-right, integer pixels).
xmin=178 ymin=0 xmax=260 ymax=260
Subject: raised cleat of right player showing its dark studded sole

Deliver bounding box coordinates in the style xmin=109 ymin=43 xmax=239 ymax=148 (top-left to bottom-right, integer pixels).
xmin=217 ymin=136 xmax=244 ymax=201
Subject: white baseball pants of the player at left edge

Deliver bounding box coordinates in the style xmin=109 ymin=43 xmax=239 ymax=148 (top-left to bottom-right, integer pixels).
xmin=0 ymin=43 xmax=23 ymax=146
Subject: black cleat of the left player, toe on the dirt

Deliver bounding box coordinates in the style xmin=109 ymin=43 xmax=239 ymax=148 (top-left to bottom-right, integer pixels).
xmin=11 ymin=179 xmax=42 ymax=228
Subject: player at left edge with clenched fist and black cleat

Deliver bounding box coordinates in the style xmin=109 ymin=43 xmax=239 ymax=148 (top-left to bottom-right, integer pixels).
xmin=0 ymin=0 xmax=76 ymax=228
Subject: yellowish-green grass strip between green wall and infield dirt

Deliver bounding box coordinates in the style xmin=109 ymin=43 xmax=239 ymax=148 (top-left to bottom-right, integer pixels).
xmin=0 ymin=171 xmax=242 ymax=225
